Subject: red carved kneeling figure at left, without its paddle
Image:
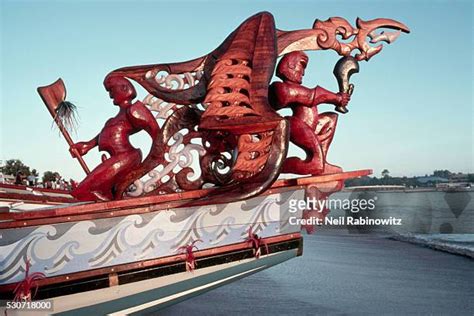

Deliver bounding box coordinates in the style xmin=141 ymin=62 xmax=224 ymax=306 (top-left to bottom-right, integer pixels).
xmin=70 ymin=75 xmax=159 ymax=200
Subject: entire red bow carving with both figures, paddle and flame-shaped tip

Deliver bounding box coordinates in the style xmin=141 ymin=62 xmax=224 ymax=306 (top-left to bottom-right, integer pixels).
xmin=39 ymin=12 xmax=408 ymax=204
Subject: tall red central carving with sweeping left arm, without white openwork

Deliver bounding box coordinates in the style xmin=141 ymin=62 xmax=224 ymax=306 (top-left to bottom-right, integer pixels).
xmin=111 ymin=12 xmax=288 ymax=203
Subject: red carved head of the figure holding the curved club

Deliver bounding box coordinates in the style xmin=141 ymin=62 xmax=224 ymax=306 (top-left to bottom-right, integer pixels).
xmin=276 ymin=51 xmax=308 ymax=84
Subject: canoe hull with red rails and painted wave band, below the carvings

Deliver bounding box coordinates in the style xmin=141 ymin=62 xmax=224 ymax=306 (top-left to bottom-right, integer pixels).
xmin=0 ymin=170 xmax=370 ymax=314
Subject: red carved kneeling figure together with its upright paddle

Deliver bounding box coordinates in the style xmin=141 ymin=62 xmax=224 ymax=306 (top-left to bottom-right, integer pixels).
xmin=38 ymin=76 xmax=159 ymax=201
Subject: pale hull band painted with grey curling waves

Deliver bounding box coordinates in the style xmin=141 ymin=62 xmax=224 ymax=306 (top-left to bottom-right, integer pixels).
xmin=0 ymin=190 xmax=304 ymax=284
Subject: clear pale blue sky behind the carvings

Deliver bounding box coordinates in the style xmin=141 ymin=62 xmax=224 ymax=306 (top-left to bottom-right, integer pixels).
xmin=0 ymin=0 xmax=474 ymax=180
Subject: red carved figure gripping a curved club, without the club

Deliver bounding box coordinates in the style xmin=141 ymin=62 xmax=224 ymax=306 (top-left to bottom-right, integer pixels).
xmin=269 ymin=52 xmax=350 ymax=175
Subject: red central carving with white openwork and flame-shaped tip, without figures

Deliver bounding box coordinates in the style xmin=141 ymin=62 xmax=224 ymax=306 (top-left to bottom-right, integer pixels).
xmin=101 ymin=12 xmax=409 ymax=203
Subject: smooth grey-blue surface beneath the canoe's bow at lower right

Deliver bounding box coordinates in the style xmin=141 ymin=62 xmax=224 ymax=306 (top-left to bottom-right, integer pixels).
xmin=160 ymin=230 xmax=474 ymax=315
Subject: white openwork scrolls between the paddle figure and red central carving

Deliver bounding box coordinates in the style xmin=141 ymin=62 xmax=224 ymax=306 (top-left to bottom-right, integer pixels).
xmin=127 ymin=70 xmax=231 ymax=197
